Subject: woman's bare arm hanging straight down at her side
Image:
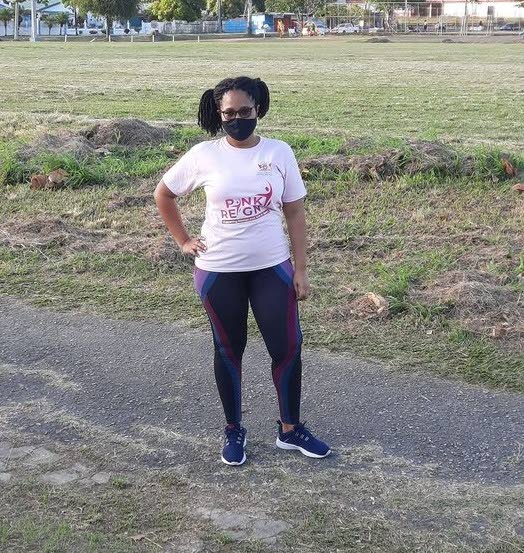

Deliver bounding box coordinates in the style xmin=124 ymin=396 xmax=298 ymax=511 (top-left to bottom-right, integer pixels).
xmin=282 ymin=199 xmax=309 ymax=300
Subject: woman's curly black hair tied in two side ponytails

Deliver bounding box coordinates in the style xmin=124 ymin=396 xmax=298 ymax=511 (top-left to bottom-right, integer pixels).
xmin=198 ymin=77 xmax=269 ymax=136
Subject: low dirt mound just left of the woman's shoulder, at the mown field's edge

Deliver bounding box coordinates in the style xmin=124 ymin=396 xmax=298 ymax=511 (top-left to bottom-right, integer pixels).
xmin=85 ymin=119 xmax=169 ymax=148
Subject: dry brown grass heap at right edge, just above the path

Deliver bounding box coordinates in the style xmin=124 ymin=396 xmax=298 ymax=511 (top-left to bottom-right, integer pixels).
xmin=410 ymin=270 xmax=524 ymax=339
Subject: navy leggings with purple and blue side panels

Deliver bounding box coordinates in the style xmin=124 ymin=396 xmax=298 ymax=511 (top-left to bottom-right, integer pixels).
xmin=194 ymin=260 xmax=302 ymax=424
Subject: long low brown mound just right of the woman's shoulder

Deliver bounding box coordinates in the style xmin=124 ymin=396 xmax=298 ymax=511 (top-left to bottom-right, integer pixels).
xmin=301 ymin=140 xmax=475 ymax=180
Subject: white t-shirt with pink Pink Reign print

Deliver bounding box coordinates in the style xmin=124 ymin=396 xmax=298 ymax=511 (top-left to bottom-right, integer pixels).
xmin=162 ymin=137 xmax=306 ymax=273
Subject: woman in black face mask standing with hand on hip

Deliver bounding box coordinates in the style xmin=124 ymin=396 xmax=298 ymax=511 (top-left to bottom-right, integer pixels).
xmin=155 ymin=77 xmax=331 ymax=465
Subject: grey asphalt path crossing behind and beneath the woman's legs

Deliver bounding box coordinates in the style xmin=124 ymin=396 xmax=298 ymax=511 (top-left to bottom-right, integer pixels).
xmin=0 ymin=298 xmax=524 ymax=483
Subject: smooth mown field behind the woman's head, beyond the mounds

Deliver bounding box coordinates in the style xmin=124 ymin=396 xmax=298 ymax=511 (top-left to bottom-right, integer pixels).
xmin=0 ymin=39 xmax=524 ymax=147
